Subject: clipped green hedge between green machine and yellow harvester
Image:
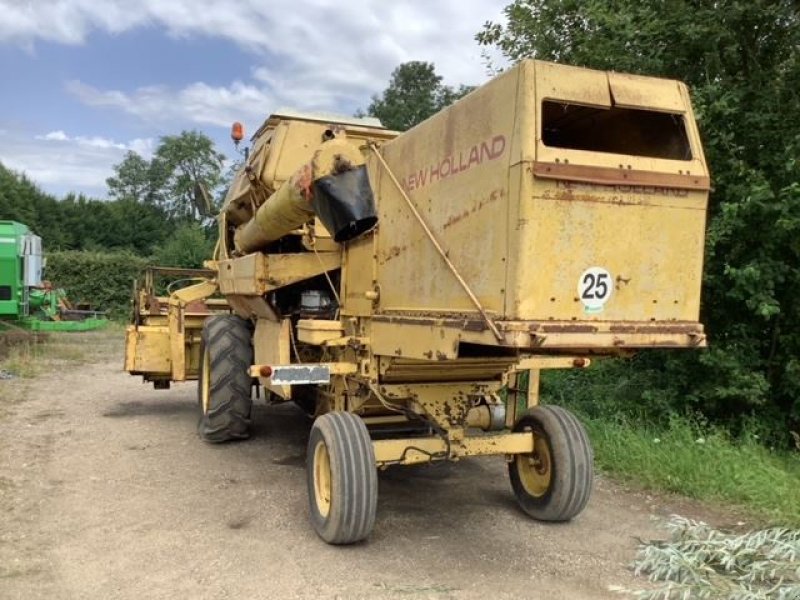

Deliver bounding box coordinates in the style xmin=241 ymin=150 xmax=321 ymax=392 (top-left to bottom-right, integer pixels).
xmin=44 ymin=250 xmax=150 ymax=318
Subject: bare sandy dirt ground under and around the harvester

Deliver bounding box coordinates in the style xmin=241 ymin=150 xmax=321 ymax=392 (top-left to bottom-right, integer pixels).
xmin=0 ymin=331 xmax=728 ymax=600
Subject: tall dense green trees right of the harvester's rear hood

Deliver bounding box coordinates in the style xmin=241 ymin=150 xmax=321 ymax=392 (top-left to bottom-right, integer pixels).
xmin=477 ymin=0 xmax=800 ymax=437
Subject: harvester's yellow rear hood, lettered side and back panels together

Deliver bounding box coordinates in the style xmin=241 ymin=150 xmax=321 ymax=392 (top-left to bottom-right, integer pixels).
xmin=362 ymin=61 xmax=709 ymax=342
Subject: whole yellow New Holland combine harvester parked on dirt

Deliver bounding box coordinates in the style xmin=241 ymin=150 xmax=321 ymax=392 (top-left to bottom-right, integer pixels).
xmin=126 ymin=60 xmax=709 ymax=544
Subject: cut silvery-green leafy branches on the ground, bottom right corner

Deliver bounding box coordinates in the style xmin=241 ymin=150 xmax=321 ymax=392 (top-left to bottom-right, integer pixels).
xmin=618 ymin=515 xmax=800 ymax=600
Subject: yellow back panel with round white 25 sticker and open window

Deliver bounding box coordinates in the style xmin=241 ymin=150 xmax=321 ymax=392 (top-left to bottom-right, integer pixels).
xmin=528 ymin=62 xmax=709 ymax=328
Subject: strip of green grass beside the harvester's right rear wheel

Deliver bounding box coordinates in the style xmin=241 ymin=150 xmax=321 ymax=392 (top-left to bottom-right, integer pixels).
xmin=541 ymin=361 xmax=800 ymax=527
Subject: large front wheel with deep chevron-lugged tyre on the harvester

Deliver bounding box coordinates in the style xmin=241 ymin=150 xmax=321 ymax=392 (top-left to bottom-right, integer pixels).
xmin=197 ymin=315 xmax=253 ymax=443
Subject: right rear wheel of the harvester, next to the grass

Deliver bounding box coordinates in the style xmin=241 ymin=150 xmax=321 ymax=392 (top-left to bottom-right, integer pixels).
xmin=508 ymin=406 xmax=594 ymax=521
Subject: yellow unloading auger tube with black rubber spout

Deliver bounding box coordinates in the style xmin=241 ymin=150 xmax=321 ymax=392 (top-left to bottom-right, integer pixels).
xmin=234 ymin=139 xmax=378 ymax=254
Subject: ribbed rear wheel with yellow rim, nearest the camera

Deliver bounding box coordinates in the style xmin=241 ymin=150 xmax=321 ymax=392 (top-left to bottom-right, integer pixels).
xmin=306 ymin=412 xmax=378 ymax=544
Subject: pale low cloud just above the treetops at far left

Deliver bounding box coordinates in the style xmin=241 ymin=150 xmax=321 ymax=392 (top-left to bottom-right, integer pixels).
xmin=0 ymin=130 xmax=155 ymax=197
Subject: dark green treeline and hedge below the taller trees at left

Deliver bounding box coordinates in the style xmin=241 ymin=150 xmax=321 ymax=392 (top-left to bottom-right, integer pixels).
xmin=0 ymin=165 xmax=214 ymax=317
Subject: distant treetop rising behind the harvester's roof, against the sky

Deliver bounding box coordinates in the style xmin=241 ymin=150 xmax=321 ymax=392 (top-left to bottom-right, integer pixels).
xmin=367 ymin=61 xmax=473 ymax=131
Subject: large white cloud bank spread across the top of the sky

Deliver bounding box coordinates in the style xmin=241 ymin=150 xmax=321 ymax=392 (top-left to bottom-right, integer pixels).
xmin=0 ymin=0 xmax=510 ymax=127
